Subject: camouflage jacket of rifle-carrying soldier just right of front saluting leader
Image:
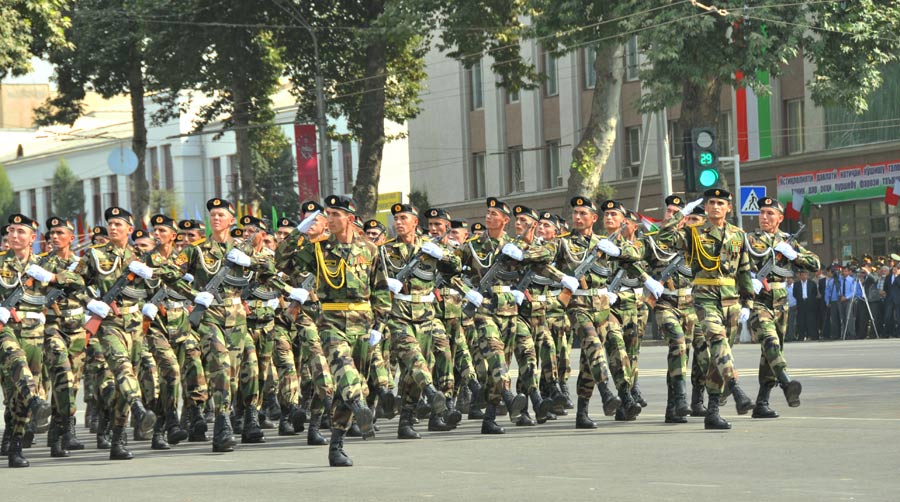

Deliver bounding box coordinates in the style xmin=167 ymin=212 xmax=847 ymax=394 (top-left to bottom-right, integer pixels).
xmin=374 ymin=236 xmax=461 ymax=321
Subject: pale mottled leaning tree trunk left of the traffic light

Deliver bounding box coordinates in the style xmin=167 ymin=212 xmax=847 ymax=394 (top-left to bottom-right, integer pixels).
xmin=563 ymin=44 xmax=625 ymax=215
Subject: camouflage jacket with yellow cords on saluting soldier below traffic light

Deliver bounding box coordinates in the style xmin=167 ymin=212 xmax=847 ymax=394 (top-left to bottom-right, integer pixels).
xmin=657 ymin=212 xmax=754 ymax=309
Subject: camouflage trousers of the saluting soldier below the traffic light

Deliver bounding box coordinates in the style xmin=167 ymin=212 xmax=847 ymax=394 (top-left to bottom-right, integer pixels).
xmin=694 ymin=298 xmax=741 ymax=394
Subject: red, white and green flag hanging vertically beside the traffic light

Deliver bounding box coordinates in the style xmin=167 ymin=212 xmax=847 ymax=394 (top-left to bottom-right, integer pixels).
xmin=735 ymin=71 xmax=772 ymax=162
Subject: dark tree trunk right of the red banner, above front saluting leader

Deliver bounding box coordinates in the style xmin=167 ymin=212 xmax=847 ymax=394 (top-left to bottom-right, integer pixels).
xmin=353 ymin=0 xmax=387 ymax=219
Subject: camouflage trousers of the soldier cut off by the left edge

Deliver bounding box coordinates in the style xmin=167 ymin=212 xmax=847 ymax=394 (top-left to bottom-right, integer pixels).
xmin=0 ymin=323 xmax=39 ymax=436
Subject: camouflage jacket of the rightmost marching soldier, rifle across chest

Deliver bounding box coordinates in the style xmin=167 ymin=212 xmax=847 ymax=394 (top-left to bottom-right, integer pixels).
xmin=747 ymin=230 xmax=820 ymax=307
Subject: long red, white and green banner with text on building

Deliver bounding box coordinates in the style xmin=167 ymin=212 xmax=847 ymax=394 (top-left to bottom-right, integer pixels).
xmin=777 ymin=160 xmax=900 ymax=205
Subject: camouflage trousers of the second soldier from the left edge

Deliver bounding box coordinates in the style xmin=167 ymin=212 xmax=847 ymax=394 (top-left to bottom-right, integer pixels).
xmin=44 ymin=316 xmax=85 ymax=417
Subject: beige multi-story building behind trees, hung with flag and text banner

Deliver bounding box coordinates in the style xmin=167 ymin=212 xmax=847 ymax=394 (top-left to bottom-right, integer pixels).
xmin=409 ymin=39 xmax=900 ymax=261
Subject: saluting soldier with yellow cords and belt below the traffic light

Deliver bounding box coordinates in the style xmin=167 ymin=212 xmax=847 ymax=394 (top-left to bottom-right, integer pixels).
xmin=658 ymin=188 xmax=754 ymax=429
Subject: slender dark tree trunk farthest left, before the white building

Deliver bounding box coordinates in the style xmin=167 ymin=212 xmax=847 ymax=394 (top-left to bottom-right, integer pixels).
xmin=126 ymin=53 xmax=150 ymax=221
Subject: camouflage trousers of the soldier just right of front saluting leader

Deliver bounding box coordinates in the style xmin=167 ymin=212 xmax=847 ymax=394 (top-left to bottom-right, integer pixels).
xmin=386 ymin=316 xmax=438 ymax=409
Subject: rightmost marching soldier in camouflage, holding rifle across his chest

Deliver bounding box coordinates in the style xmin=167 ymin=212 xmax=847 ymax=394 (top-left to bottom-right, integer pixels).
xmin=747 ymin=197 xmax=820 ymax=418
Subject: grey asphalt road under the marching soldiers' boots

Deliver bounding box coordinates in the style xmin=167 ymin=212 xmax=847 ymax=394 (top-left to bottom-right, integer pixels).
xmin=7 ymin=340 xmax=900 ymax=501
